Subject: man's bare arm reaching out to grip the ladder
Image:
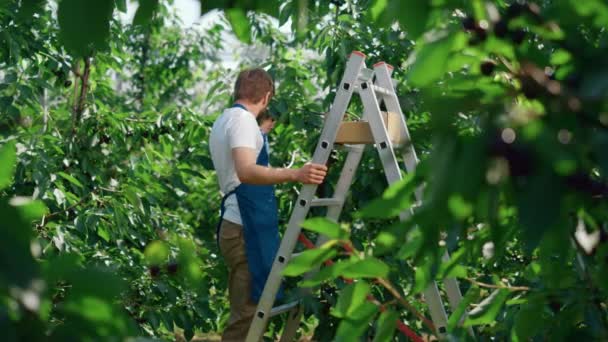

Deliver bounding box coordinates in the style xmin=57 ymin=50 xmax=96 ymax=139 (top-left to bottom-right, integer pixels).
xmin=232 ymin=147 xmax=327 ymax=185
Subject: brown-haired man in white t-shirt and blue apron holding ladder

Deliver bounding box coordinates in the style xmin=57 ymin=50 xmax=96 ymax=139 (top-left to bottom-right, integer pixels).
xmin=209 ymin=69 xmax=327 ymax=341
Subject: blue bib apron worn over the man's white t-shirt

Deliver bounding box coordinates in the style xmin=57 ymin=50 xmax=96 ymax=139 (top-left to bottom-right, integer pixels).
xmin=217 ymin=104 xmax=282 ymax=303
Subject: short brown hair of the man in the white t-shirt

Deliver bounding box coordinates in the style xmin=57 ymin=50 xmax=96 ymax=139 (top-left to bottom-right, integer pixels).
xmin=234 ymin=68 xmax=274 ymax=103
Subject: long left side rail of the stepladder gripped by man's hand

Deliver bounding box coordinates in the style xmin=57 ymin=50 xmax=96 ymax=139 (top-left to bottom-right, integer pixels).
xmin=246 ymin=52 xmax=365 ymax=342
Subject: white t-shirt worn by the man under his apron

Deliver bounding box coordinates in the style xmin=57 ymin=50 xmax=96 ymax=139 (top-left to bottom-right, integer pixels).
xmin=209 ymin=107 xmax=264 ymax=225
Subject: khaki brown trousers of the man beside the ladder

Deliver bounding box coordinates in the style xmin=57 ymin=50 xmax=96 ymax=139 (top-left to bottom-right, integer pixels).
xmin=220 ymin=220 xmax=257 ymax=342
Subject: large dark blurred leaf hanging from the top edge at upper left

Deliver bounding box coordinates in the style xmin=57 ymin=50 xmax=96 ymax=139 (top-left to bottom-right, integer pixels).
xmin=57 ymin=0 xmax=114 ymax=57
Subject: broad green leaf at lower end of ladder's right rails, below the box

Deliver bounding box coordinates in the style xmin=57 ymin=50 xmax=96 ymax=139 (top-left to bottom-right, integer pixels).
xmin=358 ymin=173 xmax=416 ymax=218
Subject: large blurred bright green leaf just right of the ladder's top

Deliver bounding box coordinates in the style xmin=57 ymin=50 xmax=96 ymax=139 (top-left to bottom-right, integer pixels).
xmin=408 ymin=32 xmax=457 ymax=88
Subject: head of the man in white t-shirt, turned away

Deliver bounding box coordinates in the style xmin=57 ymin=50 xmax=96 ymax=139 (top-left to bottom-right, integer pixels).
xmin=234 ymin=68 xmax=274 ymax=116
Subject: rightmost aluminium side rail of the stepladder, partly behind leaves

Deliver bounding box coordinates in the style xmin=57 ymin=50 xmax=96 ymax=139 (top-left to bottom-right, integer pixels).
xmin=374 ymin=63 xmax=462 ymax=316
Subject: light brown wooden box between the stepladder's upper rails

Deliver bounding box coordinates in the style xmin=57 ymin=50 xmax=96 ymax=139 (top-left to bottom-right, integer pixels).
xmin=336 ymin=112 xmax=405 ymax=145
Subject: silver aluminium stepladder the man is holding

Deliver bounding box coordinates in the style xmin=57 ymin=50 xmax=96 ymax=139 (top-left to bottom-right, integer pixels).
xmin=246 ymin=51 xmax=462 ymax=342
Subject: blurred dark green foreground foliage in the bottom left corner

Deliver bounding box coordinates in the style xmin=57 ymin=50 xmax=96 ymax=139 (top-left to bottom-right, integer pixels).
xmin=0 ymin=141 xmax=134 ymax=341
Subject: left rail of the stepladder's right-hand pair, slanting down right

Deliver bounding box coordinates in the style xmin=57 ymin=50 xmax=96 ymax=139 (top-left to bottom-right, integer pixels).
xmin=358 ymin=77 xmax=448 ymax=337
